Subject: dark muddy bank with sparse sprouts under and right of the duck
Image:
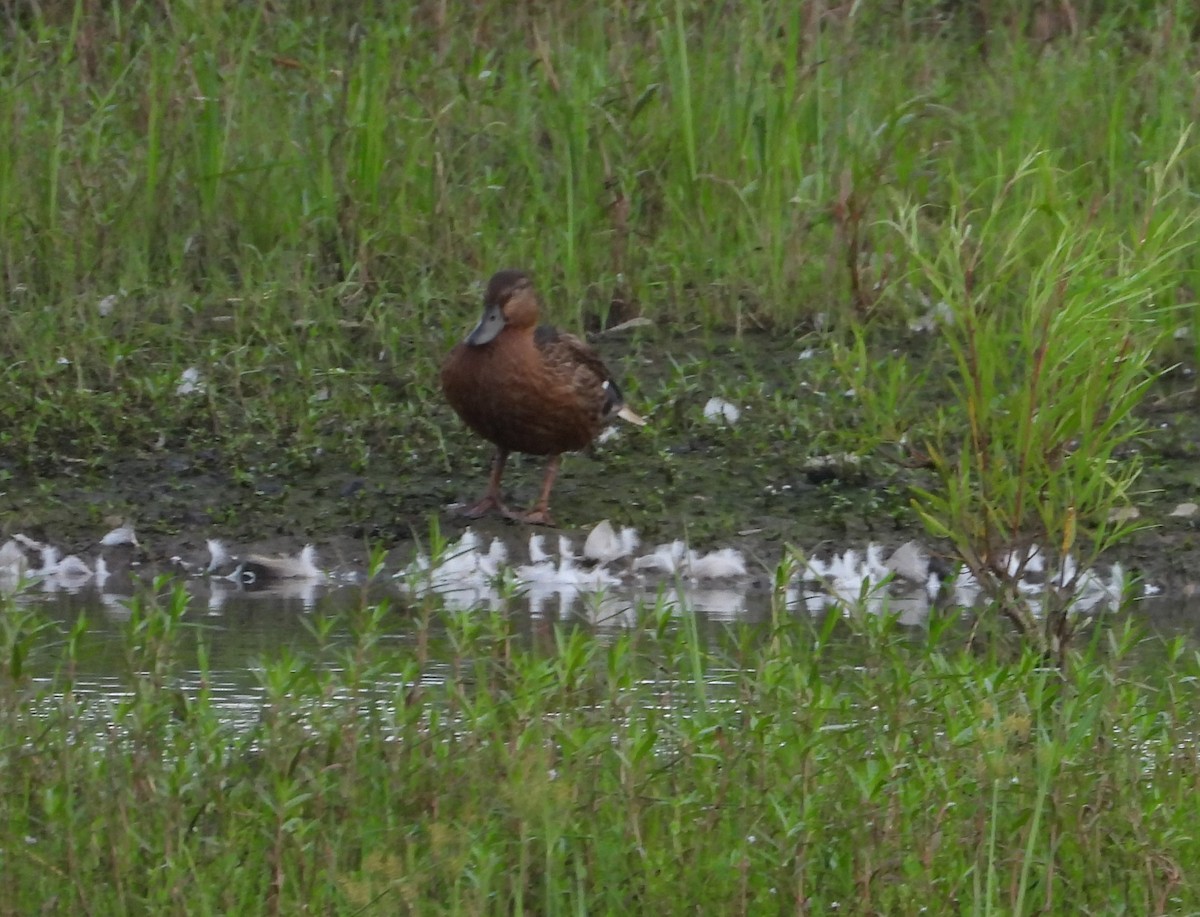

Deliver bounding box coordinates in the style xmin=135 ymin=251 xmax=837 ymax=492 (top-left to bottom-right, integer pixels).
xmin=2 ymin=338 xmax=1200 ymax=597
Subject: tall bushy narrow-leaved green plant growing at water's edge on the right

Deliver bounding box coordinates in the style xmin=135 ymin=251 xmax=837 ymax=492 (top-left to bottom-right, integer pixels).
xmin=896 ymin=143 xmax=1196 ymax=661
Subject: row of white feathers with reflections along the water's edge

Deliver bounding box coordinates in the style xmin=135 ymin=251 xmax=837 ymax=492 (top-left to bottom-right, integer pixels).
xmin=0 ymin=522 xmax=1177 ymax=685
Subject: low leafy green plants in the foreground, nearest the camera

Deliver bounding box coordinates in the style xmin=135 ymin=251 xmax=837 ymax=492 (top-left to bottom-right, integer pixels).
xmin=0 ymin=593 xmax=1200 ymax=913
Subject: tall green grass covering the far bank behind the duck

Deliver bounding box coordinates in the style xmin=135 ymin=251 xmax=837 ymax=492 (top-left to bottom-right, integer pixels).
xmin=0 ymin=0 xmax=1198 ymax=480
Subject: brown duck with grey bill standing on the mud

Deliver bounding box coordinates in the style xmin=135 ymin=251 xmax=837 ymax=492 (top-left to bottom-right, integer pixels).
xmin=442 ymin=270 xmax=646 ymax=525
